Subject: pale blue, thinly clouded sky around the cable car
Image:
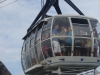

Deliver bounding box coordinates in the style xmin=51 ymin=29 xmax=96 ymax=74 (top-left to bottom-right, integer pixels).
xmin=0 ymin=0 xmax=100 ymax=75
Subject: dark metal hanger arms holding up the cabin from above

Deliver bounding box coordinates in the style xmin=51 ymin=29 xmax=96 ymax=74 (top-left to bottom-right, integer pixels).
xmin=27 ymin=0 xmax=84 ymax=32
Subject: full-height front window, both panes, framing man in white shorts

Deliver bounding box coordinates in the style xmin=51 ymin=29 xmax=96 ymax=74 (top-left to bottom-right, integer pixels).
xmin=52 ymin=17 xmax=72 ymax=56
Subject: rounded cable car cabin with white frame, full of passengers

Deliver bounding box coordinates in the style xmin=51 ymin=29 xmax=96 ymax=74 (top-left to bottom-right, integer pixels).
xmin=21 ymin=15 xmax=100 ymax=74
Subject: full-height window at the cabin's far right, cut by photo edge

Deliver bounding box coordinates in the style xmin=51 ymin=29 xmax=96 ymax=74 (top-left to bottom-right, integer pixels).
xmin=90 ymin=20 xmax=100 ymax=57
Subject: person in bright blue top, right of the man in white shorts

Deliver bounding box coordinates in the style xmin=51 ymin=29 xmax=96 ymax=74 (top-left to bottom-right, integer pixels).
xmin=66 ymin=27 xmax=72 ymax=56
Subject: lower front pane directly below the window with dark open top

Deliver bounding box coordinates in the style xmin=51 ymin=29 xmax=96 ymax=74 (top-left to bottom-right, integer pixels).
xmin=74 ymin=38 xmax=92 ymax=56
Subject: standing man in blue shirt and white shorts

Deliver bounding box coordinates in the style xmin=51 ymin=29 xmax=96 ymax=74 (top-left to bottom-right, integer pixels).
xmin=52 ymin=25 xmax=62 ymax=56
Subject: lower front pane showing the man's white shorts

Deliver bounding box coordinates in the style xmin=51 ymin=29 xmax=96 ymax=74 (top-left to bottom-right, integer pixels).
xmin=52 ymin=37 xmax=72 ymax=56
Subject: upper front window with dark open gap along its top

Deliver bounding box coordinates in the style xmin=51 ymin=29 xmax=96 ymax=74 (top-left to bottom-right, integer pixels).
xmin=71 ymin=18 xmax=91 ymax=37
